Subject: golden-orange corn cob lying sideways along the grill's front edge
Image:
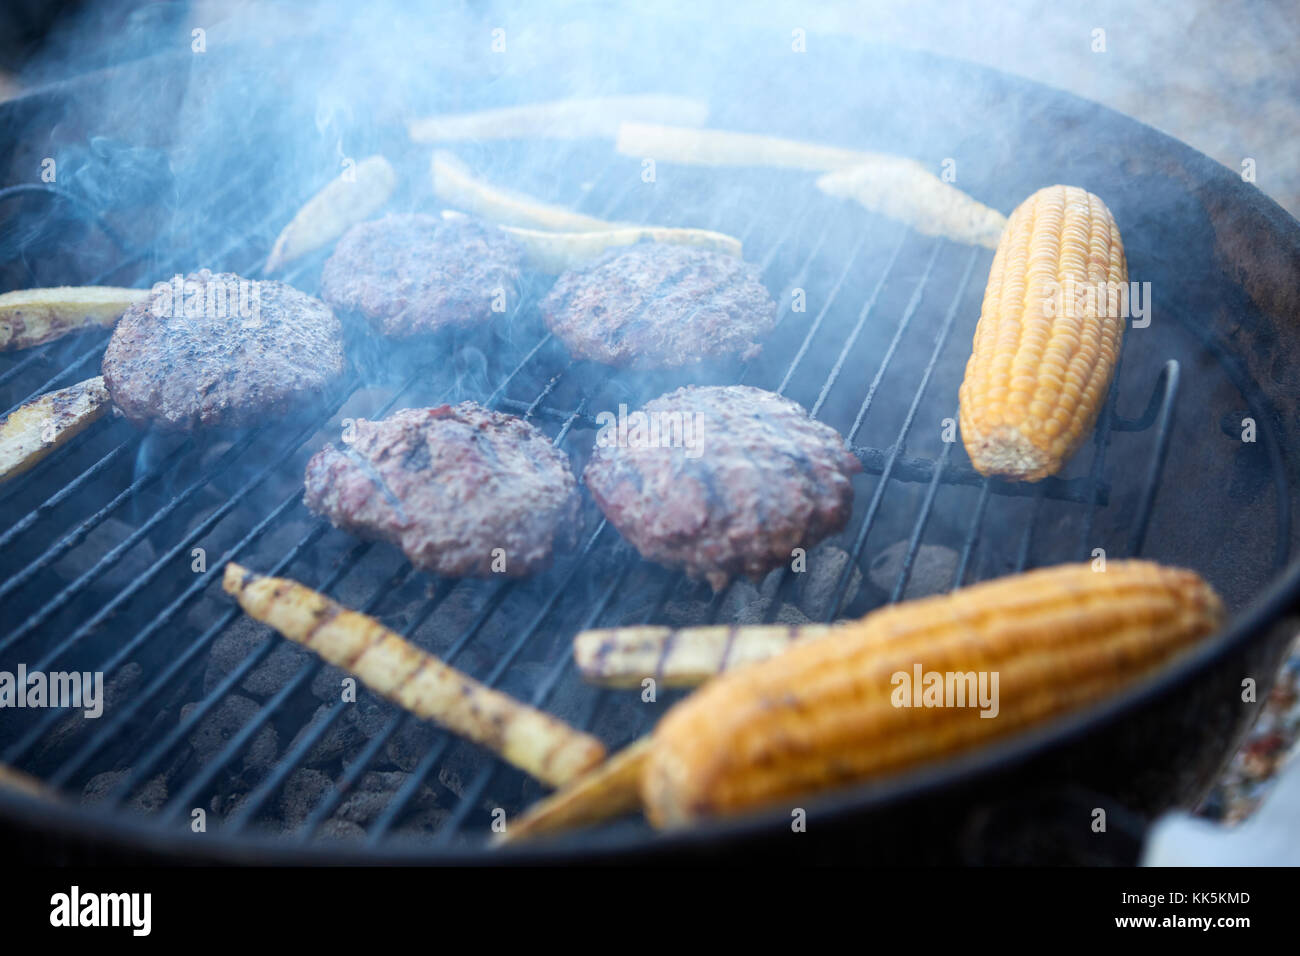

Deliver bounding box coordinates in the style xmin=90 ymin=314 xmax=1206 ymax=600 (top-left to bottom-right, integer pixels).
xmin=641 ymin=561 xmax=1223 ymax=826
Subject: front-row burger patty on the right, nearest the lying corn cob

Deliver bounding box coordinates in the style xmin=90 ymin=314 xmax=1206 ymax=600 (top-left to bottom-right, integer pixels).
xmin=584 ymin=385 xmax=862 ymax=591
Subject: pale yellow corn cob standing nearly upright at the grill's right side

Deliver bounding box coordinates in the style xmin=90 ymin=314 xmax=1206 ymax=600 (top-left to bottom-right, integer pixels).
xmin=961 ymin=186 xmax=1128 ymax=481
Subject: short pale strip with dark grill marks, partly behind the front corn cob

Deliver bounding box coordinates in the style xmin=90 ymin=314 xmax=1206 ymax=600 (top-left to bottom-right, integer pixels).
xmin=573 ymin=624 xmax=833 ymax=687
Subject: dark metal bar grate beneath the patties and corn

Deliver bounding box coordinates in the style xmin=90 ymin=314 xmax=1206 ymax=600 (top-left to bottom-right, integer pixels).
xmin=0 ymin=136 xmax=1211 ymax=845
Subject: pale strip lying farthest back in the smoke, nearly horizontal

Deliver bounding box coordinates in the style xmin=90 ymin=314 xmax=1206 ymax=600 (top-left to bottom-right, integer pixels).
xmin=407 ymin=95 xmax=709 ymax=143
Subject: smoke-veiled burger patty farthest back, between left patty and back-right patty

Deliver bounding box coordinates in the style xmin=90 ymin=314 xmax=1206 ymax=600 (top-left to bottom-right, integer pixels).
xmin=321 ymin=213 xmax=524 ymax=338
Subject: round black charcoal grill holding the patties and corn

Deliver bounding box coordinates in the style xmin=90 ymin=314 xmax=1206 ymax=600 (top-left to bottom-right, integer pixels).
xmin=0 ymin=25 xmax=1300 ymax=862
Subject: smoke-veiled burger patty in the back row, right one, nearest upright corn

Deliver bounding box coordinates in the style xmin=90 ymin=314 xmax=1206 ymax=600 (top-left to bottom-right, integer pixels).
xmin=541 ymin=242 xmax=776 ymax=368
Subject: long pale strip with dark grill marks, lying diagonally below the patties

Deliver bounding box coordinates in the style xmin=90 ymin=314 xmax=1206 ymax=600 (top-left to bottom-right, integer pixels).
xmin=224 ymin=562 xmax=605 ymax=787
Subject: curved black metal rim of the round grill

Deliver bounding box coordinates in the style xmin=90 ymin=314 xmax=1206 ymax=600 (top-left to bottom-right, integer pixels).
xmin=0 ymin=35 xmax=1300 ymax=864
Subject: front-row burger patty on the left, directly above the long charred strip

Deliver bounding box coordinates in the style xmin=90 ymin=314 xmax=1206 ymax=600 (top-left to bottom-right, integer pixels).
xmin=304 ymin=402 xmax=579 ymax=578
